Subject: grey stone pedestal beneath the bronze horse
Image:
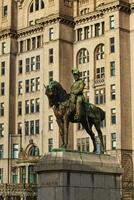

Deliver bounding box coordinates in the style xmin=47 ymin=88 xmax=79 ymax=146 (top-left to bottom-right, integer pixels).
xmin=36 ymin=151 xmax=122 ymax=200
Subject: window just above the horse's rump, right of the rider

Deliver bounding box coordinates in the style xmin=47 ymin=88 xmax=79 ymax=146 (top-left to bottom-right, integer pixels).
xmin=95 ymin=88 xmax=106 ymax=105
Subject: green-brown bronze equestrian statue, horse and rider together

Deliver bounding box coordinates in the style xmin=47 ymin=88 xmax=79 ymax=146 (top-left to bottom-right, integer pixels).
xmin=45 ymin=69 xmax=105 ymax=153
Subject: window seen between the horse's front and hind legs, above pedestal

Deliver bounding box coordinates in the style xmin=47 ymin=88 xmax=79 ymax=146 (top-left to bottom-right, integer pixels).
xmin=77 ymin=138 xmax=89 ymax=152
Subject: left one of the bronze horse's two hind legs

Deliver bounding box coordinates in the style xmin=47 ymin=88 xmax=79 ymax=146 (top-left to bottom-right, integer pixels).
xmin=82 ymin=121 xmax=97 ymax=153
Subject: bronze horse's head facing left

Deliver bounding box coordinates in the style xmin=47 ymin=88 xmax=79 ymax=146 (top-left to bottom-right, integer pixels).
xmin=45 ymin=81 xmax=58 ymax=107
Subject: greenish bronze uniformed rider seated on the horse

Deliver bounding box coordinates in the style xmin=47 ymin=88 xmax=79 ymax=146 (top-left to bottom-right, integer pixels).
xmin=70 ymin=69 xmax=85 ymax=122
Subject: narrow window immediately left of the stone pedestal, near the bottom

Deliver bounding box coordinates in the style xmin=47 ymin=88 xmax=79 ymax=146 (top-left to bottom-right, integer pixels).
xmin=28 ymin=165 xmax=37 ymax=184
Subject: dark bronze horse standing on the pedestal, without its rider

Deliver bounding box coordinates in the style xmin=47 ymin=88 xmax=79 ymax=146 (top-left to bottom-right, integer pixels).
xmin=45 ymin=81 xmax=105 ymax=153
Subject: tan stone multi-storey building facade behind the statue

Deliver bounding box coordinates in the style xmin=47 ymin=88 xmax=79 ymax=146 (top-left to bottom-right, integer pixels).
xmin=0 ymin=0 xmax=134 ymax=200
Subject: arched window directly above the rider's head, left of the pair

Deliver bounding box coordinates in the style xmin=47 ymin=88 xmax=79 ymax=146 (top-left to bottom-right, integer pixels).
xmin=77 ymin=49 xmax=89 ymax=64
